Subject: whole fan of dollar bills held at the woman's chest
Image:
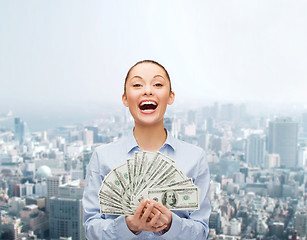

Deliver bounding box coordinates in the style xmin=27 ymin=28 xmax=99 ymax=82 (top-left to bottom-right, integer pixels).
xmin=98 ymin=152 xmax=199 ymax=215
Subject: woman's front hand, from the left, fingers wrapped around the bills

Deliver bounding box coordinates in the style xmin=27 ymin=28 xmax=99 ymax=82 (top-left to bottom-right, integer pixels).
xmin=126 ymin=200 xmax=167 ymax=233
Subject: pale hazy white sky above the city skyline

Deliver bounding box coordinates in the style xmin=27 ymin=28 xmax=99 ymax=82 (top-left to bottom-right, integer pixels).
xmin=0 ymin=0 xmax=307 ymax=118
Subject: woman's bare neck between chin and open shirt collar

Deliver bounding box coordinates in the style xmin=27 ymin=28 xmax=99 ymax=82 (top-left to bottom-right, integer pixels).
xmin=133 ymin=121 xmax=167 ymax=152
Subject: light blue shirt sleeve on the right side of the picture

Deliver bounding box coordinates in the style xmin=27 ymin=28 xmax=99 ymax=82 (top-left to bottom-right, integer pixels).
xmin=161 ymin=151 xmax=211 ymax=240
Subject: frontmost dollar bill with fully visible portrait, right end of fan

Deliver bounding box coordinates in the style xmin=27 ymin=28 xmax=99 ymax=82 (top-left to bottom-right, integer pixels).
xmin=147 ymin=186 xmax=199 ymax=211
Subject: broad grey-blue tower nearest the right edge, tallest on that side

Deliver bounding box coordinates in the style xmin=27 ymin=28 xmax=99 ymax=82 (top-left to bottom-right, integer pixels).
xmin=269 ymin=118 xmax=298 ymax=168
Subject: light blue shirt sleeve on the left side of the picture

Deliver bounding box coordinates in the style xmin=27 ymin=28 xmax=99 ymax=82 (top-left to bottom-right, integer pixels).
xmin=82 ymin=151 xmax=136 ymax=240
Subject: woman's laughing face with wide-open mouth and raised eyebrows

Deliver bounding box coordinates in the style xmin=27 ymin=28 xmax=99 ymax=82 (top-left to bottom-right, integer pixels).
xmin=122 ymin=62 xmax=175 ymax=126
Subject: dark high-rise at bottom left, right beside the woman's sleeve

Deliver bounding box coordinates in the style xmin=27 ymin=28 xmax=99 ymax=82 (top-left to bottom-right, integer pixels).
xmin=49 ymin=180 xmax=85 ymax=240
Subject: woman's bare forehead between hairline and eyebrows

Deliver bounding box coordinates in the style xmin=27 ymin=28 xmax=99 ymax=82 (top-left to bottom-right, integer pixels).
xmin=128 ymin=63 xmax=167 ymax=79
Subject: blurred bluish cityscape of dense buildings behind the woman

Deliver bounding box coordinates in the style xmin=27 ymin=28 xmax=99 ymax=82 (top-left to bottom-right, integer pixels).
xmin=0 ymin=103 xmax=307 ymax=240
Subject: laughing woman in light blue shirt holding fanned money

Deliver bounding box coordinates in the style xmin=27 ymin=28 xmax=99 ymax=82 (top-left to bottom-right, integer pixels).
xmin=83 ymin=60 xmax=210 ymax=240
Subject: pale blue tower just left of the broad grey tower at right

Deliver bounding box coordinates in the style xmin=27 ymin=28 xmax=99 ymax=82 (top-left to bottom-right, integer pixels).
xmin=246 ymin=134 xmax=265 ymax=167
